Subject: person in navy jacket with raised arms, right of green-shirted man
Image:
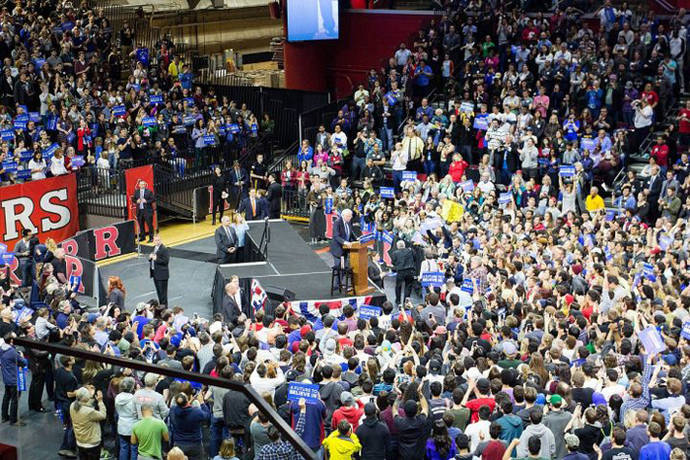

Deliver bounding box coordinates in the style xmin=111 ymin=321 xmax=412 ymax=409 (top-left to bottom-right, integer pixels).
xmin=170 ymin=391 xmax=211 ymax=460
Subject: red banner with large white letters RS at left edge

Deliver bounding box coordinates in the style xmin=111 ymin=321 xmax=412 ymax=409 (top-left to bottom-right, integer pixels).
xmin=0 ymin=174 xmax=79 ymax=251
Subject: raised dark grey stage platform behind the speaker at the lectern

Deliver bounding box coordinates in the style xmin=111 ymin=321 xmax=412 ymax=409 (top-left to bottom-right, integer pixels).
xmin=211 ymin=219 xmax=386 ymax=313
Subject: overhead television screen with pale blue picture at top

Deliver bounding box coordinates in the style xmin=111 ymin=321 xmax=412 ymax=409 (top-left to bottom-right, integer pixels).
xmin=287 ymin=0 xmax=339 ymax=42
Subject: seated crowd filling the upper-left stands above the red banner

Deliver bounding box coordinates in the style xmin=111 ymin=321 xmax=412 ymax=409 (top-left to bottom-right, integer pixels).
xmin=0 ymin=0 xmax=275 ymax=188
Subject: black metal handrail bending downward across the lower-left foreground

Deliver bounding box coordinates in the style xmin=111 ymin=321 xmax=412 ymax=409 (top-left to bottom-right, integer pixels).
xmin=14 ymin=337 xmax=317 ymax=460
